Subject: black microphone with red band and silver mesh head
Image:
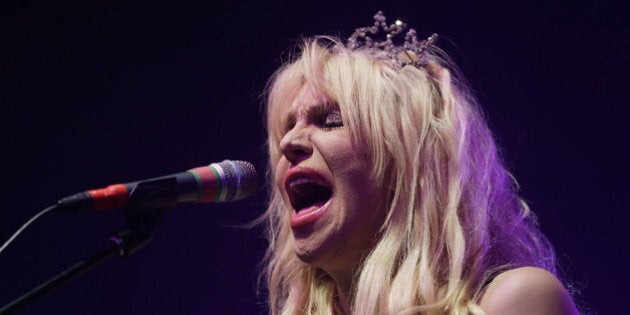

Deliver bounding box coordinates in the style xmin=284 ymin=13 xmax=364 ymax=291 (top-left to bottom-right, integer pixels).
xmin=57 ymin=160 xmax=258 ymax=211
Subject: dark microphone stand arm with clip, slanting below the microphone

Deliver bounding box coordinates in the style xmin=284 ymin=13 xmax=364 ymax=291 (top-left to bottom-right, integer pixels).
xmin=0 ymin=209 xmax=164 ymax=315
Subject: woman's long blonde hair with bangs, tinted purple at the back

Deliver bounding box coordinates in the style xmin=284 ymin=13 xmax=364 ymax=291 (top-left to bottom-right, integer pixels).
xmin=264 ymin=37 xmax=555 ymax=314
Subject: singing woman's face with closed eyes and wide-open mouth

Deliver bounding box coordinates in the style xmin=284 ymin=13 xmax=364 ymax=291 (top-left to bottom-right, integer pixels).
xmin=275 ymin=84 xmax=384 ymax=272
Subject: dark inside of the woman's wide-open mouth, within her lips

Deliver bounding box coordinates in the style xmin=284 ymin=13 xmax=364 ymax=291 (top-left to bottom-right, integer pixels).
xmin=286 ymin=177 xmax=332 ymax=213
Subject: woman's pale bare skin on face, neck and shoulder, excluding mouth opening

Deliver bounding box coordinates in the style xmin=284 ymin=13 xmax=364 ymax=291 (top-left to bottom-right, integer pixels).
xmin=276 ymin=84 xmax=578 ymax=315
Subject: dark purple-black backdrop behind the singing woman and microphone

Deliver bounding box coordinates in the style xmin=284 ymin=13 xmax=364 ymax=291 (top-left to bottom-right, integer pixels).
xmin=0 ymin=0 xmax=630 ymax=314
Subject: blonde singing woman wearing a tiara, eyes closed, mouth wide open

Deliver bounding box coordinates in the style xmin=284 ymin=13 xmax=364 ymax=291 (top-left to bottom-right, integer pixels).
xmin=265 ymin=12 xmax=576 ymax=314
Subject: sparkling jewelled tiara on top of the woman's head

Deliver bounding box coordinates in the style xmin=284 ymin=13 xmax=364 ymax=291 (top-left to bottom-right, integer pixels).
xmin=346 ymin=11 xmax=438 ymax=68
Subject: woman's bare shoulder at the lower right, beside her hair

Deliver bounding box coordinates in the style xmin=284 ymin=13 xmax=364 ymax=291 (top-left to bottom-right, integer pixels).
xmin=480 ymin=267 xmax=579 ymax=315
